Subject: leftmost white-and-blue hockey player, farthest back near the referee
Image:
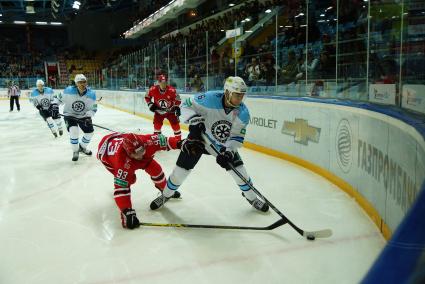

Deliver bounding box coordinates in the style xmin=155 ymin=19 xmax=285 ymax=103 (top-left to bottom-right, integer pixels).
xmin=30 ymin=79 xmax=63 ymax=137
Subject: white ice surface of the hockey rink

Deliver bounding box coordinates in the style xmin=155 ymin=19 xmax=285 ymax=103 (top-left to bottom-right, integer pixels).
xmin=0 ymin=100 xmax=385 ymax=284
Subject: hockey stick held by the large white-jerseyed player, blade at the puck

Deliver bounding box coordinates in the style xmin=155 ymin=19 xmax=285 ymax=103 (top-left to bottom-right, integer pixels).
xmin=202 ymin=133 xmax=332 ymax=240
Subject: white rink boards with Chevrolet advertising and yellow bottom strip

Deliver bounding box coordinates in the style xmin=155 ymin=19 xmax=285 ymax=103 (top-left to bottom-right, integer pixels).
xmin=97 ymin=90 xmax=425 ymax=238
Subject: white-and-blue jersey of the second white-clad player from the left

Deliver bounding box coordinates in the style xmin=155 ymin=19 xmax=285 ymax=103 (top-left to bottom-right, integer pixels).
xmin=58 ymin=86 xmax=97 ymax=118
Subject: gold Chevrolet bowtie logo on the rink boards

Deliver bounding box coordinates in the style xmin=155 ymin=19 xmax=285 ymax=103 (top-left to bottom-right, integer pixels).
xmin=281 ymin=118 xmax=320 ymax=145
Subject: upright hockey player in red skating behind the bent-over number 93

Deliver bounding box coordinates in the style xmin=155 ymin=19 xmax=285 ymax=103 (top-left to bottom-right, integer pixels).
xmin=145 ymin=75 xmax=181 ymax=139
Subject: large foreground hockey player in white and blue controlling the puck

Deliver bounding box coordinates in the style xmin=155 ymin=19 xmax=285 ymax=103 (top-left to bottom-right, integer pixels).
xmin=150 ymin=77 xmax=269 ymax=212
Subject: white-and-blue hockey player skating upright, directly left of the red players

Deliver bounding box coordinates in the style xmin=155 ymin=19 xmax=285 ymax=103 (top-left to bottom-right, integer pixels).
xmin=58 ymin=74 xmax=97 ymax=162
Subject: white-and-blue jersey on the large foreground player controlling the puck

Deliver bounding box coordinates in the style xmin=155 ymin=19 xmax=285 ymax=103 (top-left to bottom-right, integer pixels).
xmin=180 ymin=91 xmax=249 ymax=151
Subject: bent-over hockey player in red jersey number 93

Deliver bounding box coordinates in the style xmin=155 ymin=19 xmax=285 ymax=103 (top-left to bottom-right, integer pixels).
xmin=97 ymin=133 xmax=182 ymax=229
